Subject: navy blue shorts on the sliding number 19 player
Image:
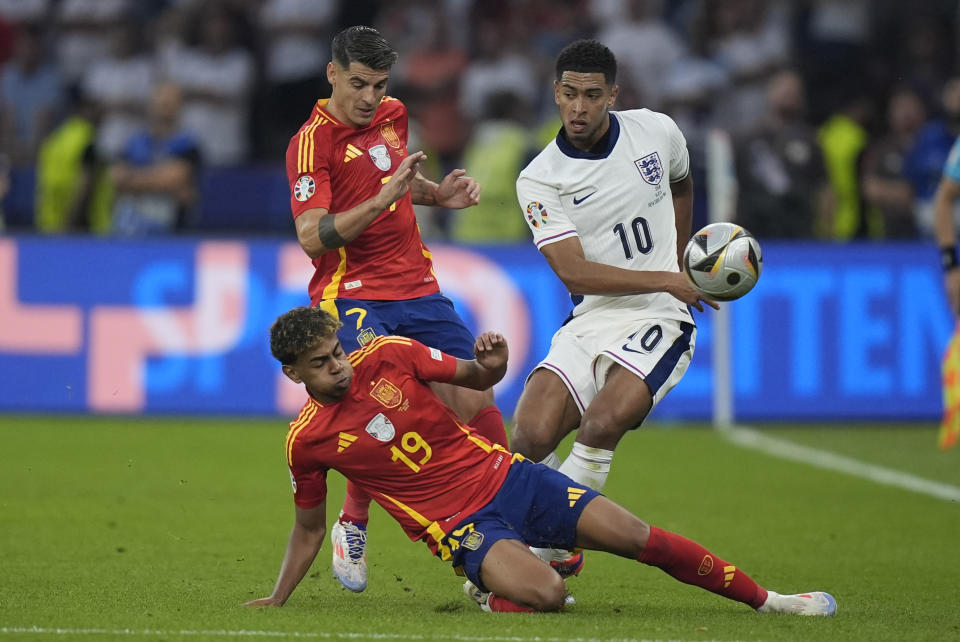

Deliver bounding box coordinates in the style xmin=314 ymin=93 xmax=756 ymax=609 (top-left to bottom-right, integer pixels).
xmin=438 ymin=459 xmax=600 ymax=591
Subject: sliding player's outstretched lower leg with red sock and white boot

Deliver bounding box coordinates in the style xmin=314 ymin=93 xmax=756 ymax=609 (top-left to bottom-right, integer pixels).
xmin=577 ymin=496 xmax=836 ymax=615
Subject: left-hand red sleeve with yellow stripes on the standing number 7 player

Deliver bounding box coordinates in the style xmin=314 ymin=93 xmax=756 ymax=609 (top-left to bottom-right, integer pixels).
xmin=287 ymin=126 xmax=332 ymax=218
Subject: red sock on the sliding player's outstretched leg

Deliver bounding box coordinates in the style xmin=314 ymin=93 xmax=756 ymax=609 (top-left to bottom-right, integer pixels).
xmin=637 ymin=526 xmax=767 ymax=608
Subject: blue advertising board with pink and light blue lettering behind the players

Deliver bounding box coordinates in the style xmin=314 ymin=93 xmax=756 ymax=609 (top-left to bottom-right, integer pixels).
xmin=0 ymin=237 xmax=952 ymax=421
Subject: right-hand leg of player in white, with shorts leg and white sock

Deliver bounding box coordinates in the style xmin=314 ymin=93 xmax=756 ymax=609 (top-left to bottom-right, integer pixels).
xmin=560 ymin=319 xmax=696 ymax=490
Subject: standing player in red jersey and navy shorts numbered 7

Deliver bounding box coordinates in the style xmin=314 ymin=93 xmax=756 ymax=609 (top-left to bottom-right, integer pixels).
xmin=287 ymin=27 xmax=507 ymax=591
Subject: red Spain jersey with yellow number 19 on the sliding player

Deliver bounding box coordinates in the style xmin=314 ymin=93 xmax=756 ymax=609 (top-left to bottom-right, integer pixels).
xmin=287 ymin=336 xmax=519 ymax=558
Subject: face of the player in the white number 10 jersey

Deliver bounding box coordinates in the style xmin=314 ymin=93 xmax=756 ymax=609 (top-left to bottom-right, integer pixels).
xmin=553 ymin=71 xmax=620 ymax=151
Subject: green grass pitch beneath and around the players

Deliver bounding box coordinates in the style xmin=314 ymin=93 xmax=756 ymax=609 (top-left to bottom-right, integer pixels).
xmin=0 ymin=416 xmax=960 ymax=642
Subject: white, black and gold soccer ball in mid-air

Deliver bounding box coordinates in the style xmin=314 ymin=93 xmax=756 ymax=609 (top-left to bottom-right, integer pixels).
xmin=683 ymin=223 xmax=763 ymax=301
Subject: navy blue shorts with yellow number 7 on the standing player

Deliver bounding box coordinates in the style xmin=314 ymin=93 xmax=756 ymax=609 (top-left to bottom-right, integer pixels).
xmin=321 ymin=292 xmax=474 ymax=359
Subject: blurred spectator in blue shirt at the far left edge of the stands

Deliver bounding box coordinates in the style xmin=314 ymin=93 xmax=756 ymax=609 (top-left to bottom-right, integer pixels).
xmin=0 ymin=25 xmax=65 ymax=167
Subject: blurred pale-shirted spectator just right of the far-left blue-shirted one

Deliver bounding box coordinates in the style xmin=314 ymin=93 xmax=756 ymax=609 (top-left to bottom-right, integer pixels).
xmin=82 ymin=22 xmax=156 ymax=160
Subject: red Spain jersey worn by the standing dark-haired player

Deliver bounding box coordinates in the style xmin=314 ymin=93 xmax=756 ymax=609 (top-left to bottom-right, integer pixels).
xmin=287 ymin=96 xmax=440 ymax=305
